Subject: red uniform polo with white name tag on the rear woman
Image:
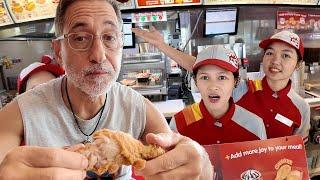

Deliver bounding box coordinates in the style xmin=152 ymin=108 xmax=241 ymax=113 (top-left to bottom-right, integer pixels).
xmin=236 ymin=78 xmax=310 ymax=141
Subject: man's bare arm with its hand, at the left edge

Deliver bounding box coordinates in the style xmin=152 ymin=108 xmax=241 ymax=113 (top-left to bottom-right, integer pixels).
xmin=0 ymin=100 xmax=88 ymax=180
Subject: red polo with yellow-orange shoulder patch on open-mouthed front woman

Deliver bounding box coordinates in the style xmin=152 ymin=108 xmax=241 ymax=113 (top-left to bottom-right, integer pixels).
xmin=170 ymin=99 xmax=266 ymax=145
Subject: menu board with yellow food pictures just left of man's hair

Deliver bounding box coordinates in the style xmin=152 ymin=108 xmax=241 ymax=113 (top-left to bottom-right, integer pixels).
xmin=6 ymin=0 xmax=59 ymax=23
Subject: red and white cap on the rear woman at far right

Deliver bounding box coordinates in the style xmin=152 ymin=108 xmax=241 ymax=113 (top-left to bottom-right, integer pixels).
xmin=259 ymin=31 xmax=304 ymax=59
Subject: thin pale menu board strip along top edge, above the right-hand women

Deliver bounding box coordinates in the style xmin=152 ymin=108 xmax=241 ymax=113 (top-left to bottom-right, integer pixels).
xmin=204 ymin=0 xmax=318 ymax=5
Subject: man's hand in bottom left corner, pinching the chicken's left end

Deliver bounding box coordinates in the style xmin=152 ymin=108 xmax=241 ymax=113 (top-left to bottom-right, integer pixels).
xmin=0 ymin=146 xmax=88 ymax=180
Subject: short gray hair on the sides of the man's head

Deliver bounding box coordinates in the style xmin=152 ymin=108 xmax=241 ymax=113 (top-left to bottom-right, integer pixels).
xmin=54 ymin=0 xmax=123 ymax=37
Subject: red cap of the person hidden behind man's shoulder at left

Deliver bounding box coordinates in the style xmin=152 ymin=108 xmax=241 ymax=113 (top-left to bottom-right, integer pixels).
xmin=17 ymin=62 xmax=64 ymax=94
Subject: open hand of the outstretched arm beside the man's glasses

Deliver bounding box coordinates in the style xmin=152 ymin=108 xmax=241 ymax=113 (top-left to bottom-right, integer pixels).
xmin=132 ymin=26 xmax=164 ymax=47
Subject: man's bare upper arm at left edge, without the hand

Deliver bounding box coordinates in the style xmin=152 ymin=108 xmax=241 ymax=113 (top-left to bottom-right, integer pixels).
xmin=0 ymin=100 xmax=23 ymax=163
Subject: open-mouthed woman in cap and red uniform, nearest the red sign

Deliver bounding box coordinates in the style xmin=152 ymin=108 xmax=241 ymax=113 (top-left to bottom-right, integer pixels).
xmin=170 ymin=45 xmax=266 ymax=145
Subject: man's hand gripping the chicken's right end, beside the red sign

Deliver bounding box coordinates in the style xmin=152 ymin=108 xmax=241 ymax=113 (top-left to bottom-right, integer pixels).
xmin=136 ymin=133 xmax=213 ymax=180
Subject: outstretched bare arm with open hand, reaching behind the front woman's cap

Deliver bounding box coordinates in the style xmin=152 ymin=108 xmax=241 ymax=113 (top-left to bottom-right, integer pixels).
xmin=132 ymin=26 xmax=196 ymax=71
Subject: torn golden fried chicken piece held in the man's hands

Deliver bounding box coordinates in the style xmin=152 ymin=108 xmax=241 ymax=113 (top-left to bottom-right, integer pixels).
xmin=76 ymin=129 xmax=165 ymax=175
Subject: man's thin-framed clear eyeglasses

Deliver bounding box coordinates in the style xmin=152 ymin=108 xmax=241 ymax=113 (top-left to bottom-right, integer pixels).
xmin=56 ymin=31 xmax=123 ymax=51
